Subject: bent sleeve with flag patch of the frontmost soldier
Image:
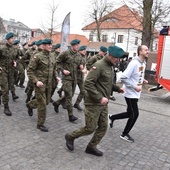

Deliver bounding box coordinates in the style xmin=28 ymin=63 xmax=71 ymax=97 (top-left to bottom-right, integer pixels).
xmin=84 ymin=66 xmax=103 ymax=102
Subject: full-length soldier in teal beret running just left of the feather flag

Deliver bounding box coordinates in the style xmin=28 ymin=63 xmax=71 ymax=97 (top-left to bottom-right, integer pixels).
xmin=26 ymin=39 xmax=58 ymax=132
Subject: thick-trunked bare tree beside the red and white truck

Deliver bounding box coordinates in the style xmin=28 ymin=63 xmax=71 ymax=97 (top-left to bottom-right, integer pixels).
xmin=123 ymin=0 xmax=170 ymax=50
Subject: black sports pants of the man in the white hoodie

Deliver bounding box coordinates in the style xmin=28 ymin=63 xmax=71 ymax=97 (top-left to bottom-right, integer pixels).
xmin=112 ymin=97 xmax=139 ymax=135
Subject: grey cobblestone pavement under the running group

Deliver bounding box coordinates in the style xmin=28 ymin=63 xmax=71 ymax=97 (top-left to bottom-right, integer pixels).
xmin=0 ymin=81 xmax=170 ymax=170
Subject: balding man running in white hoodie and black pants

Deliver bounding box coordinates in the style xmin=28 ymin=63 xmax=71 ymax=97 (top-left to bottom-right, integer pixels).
xmin=109 ymin=45 xmax=149 ymax=142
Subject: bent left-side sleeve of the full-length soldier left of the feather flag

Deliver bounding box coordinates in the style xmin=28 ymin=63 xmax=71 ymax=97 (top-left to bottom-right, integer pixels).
xmin=27 ymin=55 xmax=39 ymax=84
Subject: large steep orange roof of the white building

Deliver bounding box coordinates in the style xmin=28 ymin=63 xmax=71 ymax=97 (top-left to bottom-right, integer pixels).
xmin=82 ymin=5 xmax=142 ymax=30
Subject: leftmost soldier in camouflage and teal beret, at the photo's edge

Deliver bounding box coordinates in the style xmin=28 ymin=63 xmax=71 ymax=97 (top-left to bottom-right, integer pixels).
xmin=0 ymin=32 xmax=18 ymax=116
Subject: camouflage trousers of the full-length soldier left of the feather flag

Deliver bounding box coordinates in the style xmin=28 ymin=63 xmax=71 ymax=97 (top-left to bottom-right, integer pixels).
xmin=28 ymin=86 xmax=47 ymax=125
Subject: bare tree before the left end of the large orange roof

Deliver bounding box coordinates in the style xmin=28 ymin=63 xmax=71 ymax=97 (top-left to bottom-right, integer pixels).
xmin=86 ymin=0 xmax=114 ymax=42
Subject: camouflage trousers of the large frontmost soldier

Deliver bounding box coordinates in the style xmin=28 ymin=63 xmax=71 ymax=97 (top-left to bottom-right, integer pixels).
xmin=69 ymin=105 xmax=108 ymax=148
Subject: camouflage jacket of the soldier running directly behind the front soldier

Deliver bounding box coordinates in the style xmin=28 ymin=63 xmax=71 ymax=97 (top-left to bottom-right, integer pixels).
xmin=56 ymin=50 xmax=83 ymax=81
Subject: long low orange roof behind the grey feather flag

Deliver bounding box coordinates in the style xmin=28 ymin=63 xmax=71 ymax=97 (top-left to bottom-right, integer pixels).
xmin=31 ymin=32 xmax=89 ymax=46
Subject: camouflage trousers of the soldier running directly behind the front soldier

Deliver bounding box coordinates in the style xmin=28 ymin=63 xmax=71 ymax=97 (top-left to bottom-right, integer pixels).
xmin=56 ymin=80 xmax=77 ymax=116
